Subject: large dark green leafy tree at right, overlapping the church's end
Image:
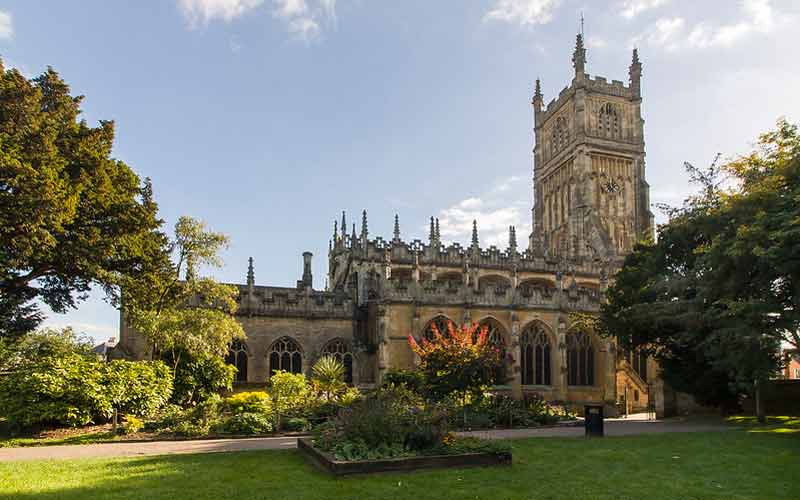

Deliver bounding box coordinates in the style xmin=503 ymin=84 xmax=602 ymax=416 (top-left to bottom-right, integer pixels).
xmin=600 ymin=121 xmax=800 ymax=407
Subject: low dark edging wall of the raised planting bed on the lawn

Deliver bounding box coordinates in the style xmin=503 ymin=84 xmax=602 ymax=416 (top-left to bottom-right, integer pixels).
xmin=297 ymin=438 xmax=511 ymax=476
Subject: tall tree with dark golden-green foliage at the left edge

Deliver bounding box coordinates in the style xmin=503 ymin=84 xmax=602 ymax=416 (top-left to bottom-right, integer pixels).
xmin=0 ymin=62 xmax=167 ymax=337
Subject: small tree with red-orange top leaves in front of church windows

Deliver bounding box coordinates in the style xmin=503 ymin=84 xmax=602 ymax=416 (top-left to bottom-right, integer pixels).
xmin=408 ymin=322 xmax=501 ymax=401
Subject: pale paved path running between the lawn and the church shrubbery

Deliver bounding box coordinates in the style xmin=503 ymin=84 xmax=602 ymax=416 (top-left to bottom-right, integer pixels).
xmin=0 ymin=419 xmax=729 ymax=462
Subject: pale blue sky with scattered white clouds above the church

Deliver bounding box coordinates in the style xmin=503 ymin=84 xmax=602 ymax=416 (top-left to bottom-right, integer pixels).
xmin=0 ymin=0 xmax=800 ymax=340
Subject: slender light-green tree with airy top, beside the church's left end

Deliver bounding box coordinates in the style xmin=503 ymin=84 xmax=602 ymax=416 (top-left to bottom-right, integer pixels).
xmin=125 ymin=217 xmax=244 ymax=403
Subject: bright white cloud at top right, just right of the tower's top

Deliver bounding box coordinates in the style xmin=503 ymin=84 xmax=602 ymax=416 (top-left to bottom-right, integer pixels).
xmin=633 ymin=0 xmax=775 ymax=50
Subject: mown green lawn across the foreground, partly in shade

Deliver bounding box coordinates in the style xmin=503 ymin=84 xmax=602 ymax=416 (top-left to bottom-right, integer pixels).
xmin=0 ymin=430 xmax=800 ymax=500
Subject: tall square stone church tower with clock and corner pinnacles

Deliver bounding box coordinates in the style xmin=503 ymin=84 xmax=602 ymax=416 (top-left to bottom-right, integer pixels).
xmin=530 ymin=35 xmax=653 ymax=261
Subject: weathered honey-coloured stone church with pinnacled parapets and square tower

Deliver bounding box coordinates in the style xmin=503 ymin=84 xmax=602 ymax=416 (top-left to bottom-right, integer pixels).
xmin=120 ymin=35 xmax=666 ymax=414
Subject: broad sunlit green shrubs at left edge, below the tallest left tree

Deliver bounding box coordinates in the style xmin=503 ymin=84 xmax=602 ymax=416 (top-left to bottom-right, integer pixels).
xmin=0 ymin=329 xmax=172 ymax=427
